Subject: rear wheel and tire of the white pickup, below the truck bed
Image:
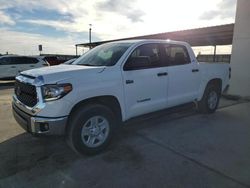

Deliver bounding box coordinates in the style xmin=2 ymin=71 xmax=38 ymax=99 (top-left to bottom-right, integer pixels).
xmin=198 ymin=84 xmax=221 ymax=114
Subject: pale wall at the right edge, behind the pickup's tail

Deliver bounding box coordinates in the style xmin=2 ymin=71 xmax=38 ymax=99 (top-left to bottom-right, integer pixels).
xmin=228 ymin=0 xmax=250 ymax=97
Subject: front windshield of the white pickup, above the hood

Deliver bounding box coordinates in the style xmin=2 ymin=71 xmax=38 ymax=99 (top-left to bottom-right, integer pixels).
xmin=73 ymin=43 xmax=132 ymax=66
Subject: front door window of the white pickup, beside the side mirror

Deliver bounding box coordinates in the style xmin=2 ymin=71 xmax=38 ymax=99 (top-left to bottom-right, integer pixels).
xmin=124 ymin=44 xmax=161 ymax=70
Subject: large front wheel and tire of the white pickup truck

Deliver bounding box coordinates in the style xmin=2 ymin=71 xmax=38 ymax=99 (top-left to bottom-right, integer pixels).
xmin=66 ymin=104 xmax=116 ymax=155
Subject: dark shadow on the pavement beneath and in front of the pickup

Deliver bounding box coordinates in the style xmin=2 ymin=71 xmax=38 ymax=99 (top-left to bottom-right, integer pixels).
xmin=0 ymin=103 xmax=194 ymax=179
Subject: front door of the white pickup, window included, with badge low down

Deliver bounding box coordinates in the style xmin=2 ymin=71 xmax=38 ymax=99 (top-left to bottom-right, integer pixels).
xmin=122 ymin=43 xmax=167 ymax=118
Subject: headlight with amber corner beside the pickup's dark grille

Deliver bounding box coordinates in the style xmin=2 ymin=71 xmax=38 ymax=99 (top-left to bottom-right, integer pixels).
xmin=42 ymin=84 xmax=72 ymax=101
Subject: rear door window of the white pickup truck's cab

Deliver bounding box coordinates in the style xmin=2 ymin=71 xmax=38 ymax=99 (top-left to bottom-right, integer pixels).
xmin=164 ymin=45 xmax=190 ymax=66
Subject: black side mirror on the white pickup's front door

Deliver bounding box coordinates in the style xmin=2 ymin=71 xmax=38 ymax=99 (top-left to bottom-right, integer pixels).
xmin=123 ymin=56 xmax=150 ymax=71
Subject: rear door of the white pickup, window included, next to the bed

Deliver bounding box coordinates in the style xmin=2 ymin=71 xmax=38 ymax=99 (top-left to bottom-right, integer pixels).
xmin=163 ymin=44 xmax=200 ymax=107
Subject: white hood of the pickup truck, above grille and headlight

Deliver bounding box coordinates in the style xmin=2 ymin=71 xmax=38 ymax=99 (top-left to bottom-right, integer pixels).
xmin=21 ymin=65 xmax=105 ymax=84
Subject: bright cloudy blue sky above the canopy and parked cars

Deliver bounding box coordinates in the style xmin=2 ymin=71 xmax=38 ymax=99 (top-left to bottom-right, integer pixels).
xmin=0 ymin=0 xmax=236 ymax=55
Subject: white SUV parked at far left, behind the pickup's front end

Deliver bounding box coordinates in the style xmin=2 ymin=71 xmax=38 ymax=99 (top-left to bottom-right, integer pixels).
xmin=0 ymin=55 xmax=49 ymax=79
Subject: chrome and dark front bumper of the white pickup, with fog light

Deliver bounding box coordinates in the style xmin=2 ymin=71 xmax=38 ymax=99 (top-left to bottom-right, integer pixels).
xmin=12 ymin=102 xmax=68 ymax=135
